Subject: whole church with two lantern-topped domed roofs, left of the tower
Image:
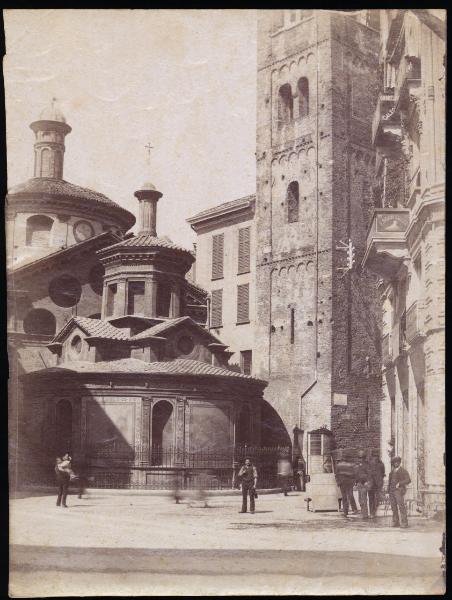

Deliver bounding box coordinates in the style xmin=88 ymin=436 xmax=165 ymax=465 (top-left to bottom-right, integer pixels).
xmin=7 ymin=106 xmax=268 ymax=490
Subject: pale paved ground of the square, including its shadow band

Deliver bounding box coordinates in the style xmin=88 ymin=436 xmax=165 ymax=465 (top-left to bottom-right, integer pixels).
xmin=10 ymin=490 xmax=443 ymax=596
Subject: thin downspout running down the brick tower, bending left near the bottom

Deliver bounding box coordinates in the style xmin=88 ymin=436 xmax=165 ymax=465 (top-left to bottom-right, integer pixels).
xmin=298 ymin=12 xmax=319 ymax=434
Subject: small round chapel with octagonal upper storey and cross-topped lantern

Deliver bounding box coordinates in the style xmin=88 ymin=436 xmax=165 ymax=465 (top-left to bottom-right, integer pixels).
xmin=23 ymin=168 xmax=266 ymax=487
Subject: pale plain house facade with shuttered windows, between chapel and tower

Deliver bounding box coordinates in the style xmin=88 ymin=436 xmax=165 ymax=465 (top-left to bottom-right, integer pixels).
xmin=187 ymin=196 xmax=256 ymax=375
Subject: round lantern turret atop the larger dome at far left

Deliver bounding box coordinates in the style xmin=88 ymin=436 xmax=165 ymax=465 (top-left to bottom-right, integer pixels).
xmin=30 ymin=98 xmax=72 ymax=179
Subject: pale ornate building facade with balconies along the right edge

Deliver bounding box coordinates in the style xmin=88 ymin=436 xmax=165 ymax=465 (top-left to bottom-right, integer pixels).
xmin=363 ymin=10 xmax=446 ymax=512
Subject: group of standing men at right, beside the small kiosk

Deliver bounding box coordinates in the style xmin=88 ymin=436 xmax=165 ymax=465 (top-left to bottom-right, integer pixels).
xmin=335 ymin=450 xmax=411 ymax=528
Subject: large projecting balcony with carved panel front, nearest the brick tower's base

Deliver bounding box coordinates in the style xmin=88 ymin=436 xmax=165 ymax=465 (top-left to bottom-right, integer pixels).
xmin=362 ymin=208 xmax=410 ymax=280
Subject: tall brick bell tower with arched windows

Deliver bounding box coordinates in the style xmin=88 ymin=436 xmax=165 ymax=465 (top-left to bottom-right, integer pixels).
xmin=255 ymin=10 xmax=381 ymax=468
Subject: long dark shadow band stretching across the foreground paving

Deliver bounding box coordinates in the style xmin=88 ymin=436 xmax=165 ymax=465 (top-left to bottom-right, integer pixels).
xmin=10 ymin=545 xmax=441 ymax=578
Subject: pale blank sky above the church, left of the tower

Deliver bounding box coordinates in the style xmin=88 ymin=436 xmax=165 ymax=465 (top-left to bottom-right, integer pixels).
xmin=4 ymin=9 xmax=256 ymax=247
